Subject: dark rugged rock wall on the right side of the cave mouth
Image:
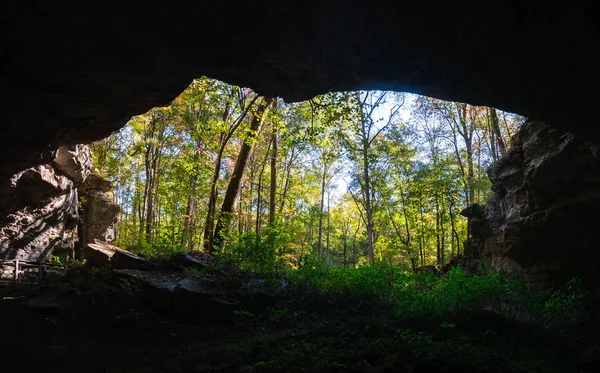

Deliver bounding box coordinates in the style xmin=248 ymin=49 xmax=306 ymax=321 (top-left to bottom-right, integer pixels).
xmin=486 ymin=122 xmax=600 ymax=289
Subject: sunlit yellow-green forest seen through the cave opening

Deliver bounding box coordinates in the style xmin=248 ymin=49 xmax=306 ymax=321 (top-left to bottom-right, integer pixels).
xmin=93 ymin=78 xmax=523 ymax=269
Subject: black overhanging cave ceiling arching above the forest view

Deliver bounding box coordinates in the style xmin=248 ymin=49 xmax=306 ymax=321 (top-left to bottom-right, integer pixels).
xmin=0 ymin=0 xmax=600 ymax=177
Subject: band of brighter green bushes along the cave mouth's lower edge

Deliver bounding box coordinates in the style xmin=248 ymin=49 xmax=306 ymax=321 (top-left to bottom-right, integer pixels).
xmin=288 ymin=258 xmax=584 ymax=326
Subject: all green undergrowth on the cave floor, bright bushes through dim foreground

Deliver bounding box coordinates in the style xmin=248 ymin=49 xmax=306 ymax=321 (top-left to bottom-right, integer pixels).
xmin=205 ymin=259 xmax=583 ymax=373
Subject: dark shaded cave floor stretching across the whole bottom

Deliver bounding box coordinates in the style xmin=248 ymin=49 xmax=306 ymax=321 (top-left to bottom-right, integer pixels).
xmin=0 ymin=274 xmax=597 ymax=373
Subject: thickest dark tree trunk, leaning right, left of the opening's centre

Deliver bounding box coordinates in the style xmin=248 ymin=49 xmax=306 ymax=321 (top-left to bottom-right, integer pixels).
xmin=209 ymin=98 xmax=275 ymax=253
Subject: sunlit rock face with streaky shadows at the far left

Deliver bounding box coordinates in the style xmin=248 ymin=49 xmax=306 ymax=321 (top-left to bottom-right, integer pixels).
xmin=0 ymin=145 xmax=92 ymax=261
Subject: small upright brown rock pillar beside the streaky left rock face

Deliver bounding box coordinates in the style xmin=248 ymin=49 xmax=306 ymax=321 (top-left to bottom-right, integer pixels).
xmin=76 ymin=172 xmax=120 ymax=256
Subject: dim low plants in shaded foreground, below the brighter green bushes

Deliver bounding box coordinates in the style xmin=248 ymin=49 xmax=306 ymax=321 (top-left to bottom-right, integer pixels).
xmin=217 ymin=299 xmax=573 ymax=373
